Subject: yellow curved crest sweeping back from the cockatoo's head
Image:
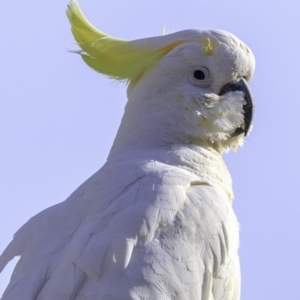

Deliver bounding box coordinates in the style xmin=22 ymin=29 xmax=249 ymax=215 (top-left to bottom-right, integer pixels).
xmin=67 ymin=0 xmax=185 ymax=83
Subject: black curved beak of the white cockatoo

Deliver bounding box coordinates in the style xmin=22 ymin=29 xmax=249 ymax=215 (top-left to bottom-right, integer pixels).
xmin=219 ymin=78 xmax=254 ymax=136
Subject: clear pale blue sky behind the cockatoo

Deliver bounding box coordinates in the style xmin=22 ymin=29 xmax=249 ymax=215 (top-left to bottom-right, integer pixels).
xmin=0 ymin=0 xmax=300 ymax=300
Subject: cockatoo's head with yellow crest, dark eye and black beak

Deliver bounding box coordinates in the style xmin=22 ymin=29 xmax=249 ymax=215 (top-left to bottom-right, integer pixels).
xmin=67 ymin=0 xmax=255 ymax=151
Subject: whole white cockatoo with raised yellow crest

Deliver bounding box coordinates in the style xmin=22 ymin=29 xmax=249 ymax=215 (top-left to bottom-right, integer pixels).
xmin=0 ymin=1 xmax=255 ymax=300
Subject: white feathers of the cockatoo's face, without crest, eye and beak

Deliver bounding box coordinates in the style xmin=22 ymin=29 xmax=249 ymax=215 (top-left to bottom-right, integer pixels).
xmin=113 ymin=30 xmax=254 ymax=157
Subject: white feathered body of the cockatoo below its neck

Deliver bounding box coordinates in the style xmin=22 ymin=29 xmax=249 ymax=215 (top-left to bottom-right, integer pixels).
xmin=1 ymin=146 xmax=238 ymax=300
